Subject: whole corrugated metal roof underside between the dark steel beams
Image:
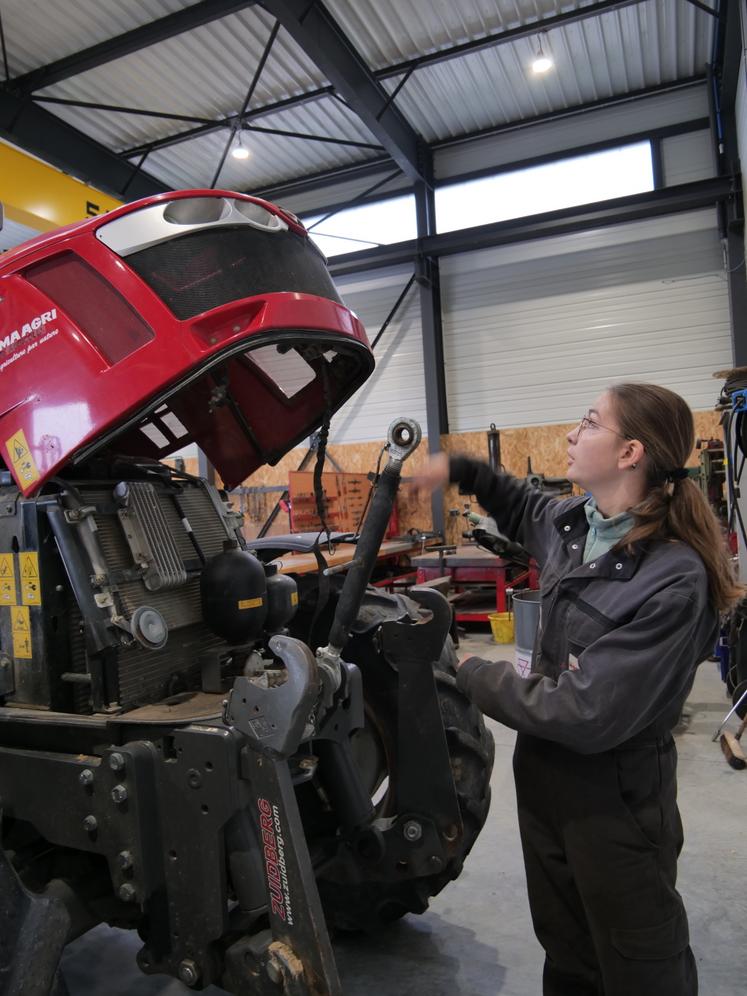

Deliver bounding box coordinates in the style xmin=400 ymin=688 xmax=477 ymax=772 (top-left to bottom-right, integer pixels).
xmin=2 ymin=0 xmax=715 ymax=195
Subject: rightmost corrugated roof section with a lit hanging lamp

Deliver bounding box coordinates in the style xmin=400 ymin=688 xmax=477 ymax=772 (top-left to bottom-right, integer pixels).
xmin=385 ymin=0 xmax=713 ymax=142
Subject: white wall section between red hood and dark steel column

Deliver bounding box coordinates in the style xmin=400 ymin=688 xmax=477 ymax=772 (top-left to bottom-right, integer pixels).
xmin=330 ymin=267 xmax=425 ymax=443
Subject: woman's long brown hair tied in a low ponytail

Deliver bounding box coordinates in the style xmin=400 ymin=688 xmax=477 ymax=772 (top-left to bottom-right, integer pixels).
xmin=609 ymin=383 xmax=744 ymax=611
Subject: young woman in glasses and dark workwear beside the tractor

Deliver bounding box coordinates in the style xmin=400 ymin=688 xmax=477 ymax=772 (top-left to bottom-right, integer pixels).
xmin=421 ymin=384 xmax=741 ymax=996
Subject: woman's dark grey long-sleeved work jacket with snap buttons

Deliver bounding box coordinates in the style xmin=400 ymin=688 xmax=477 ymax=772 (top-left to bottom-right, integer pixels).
xmin=450 ymin=457 xmax=718 ymax=754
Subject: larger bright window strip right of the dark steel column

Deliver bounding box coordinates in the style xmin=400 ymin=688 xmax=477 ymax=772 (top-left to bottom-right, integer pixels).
xmin=436 ymin=142 xmax=654 ymax=232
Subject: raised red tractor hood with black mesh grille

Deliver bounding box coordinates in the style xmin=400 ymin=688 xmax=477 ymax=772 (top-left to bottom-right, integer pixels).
xmin=0 ymin=190 xmax=373 ymax=495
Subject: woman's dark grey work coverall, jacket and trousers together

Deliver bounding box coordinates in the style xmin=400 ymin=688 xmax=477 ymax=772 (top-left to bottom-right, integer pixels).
xmin=450 ymin=457 xmax=718 ymax=996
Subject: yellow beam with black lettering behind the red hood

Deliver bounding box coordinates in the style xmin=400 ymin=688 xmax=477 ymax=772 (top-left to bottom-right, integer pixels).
xmin=0 ymin=142 xmax=122 ymax=232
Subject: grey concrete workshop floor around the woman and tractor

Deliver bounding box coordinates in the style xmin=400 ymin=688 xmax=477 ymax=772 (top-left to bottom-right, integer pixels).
xmin=63 ymin=632 xmax=747 ymax=996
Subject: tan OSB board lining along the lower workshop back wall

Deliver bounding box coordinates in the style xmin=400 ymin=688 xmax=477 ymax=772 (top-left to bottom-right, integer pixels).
xmin=202 ymin=411 xmax=721 ymax=543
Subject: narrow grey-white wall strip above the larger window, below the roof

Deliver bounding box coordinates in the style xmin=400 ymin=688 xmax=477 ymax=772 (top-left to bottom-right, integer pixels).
xmin=434 ymin=84 xmax=708 ymax=180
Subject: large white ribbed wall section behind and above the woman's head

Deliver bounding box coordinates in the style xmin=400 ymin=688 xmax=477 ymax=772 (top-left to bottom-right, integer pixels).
xmin=441 ymin=210 xmax=732 ymax=432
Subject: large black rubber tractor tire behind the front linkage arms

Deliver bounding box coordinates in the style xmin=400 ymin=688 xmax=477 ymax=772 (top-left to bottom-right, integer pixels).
xmin=318 ymin=636 xmax=495 ymax=931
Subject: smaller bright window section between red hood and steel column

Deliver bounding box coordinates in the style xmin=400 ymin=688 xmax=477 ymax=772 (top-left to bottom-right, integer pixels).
xmin=303 ymin=194 xmax=417 ymax=258
